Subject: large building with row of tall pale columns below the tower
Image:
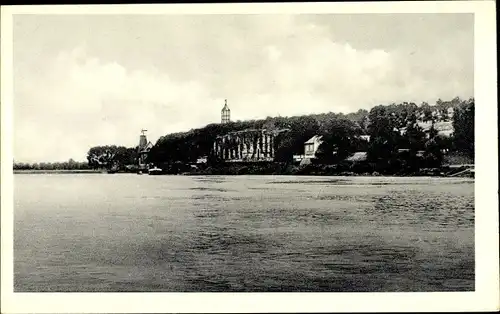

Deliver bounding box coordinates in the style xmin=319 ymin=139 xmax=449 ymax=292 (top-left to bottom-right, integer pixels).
xmin=213 ymin=129 xmax=288 ymax=162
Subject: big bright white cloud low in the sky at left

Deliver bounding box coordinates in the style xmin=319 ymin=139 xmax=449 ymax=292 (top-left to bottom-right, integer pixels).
xmin=14 ymin=49 xmax=218 ymax=160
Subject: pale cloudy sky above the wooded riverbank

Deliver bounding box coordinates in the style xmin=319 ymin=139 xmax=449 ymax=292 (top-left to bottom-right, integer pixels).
xmin=13 ymin=14 xmax=474 ymax=162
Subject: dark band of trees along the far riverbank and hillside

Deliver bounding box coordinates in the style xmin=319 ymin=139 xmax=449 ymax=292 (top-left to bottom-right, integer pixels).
xmin=10 ymin=97 xmax=474 ymax=172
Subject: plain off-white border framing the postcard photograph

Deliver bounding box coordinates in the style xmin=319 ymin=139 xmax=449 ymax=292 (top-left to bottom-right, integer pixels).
xmin=1 ymin=1 xmax=499 ymax=313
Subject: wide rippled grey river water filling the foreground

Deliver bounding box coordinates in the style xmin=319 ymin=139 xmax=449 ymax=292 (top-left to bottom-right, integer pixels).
xmin=14 ymin=174 xmax=474 ymax=292
